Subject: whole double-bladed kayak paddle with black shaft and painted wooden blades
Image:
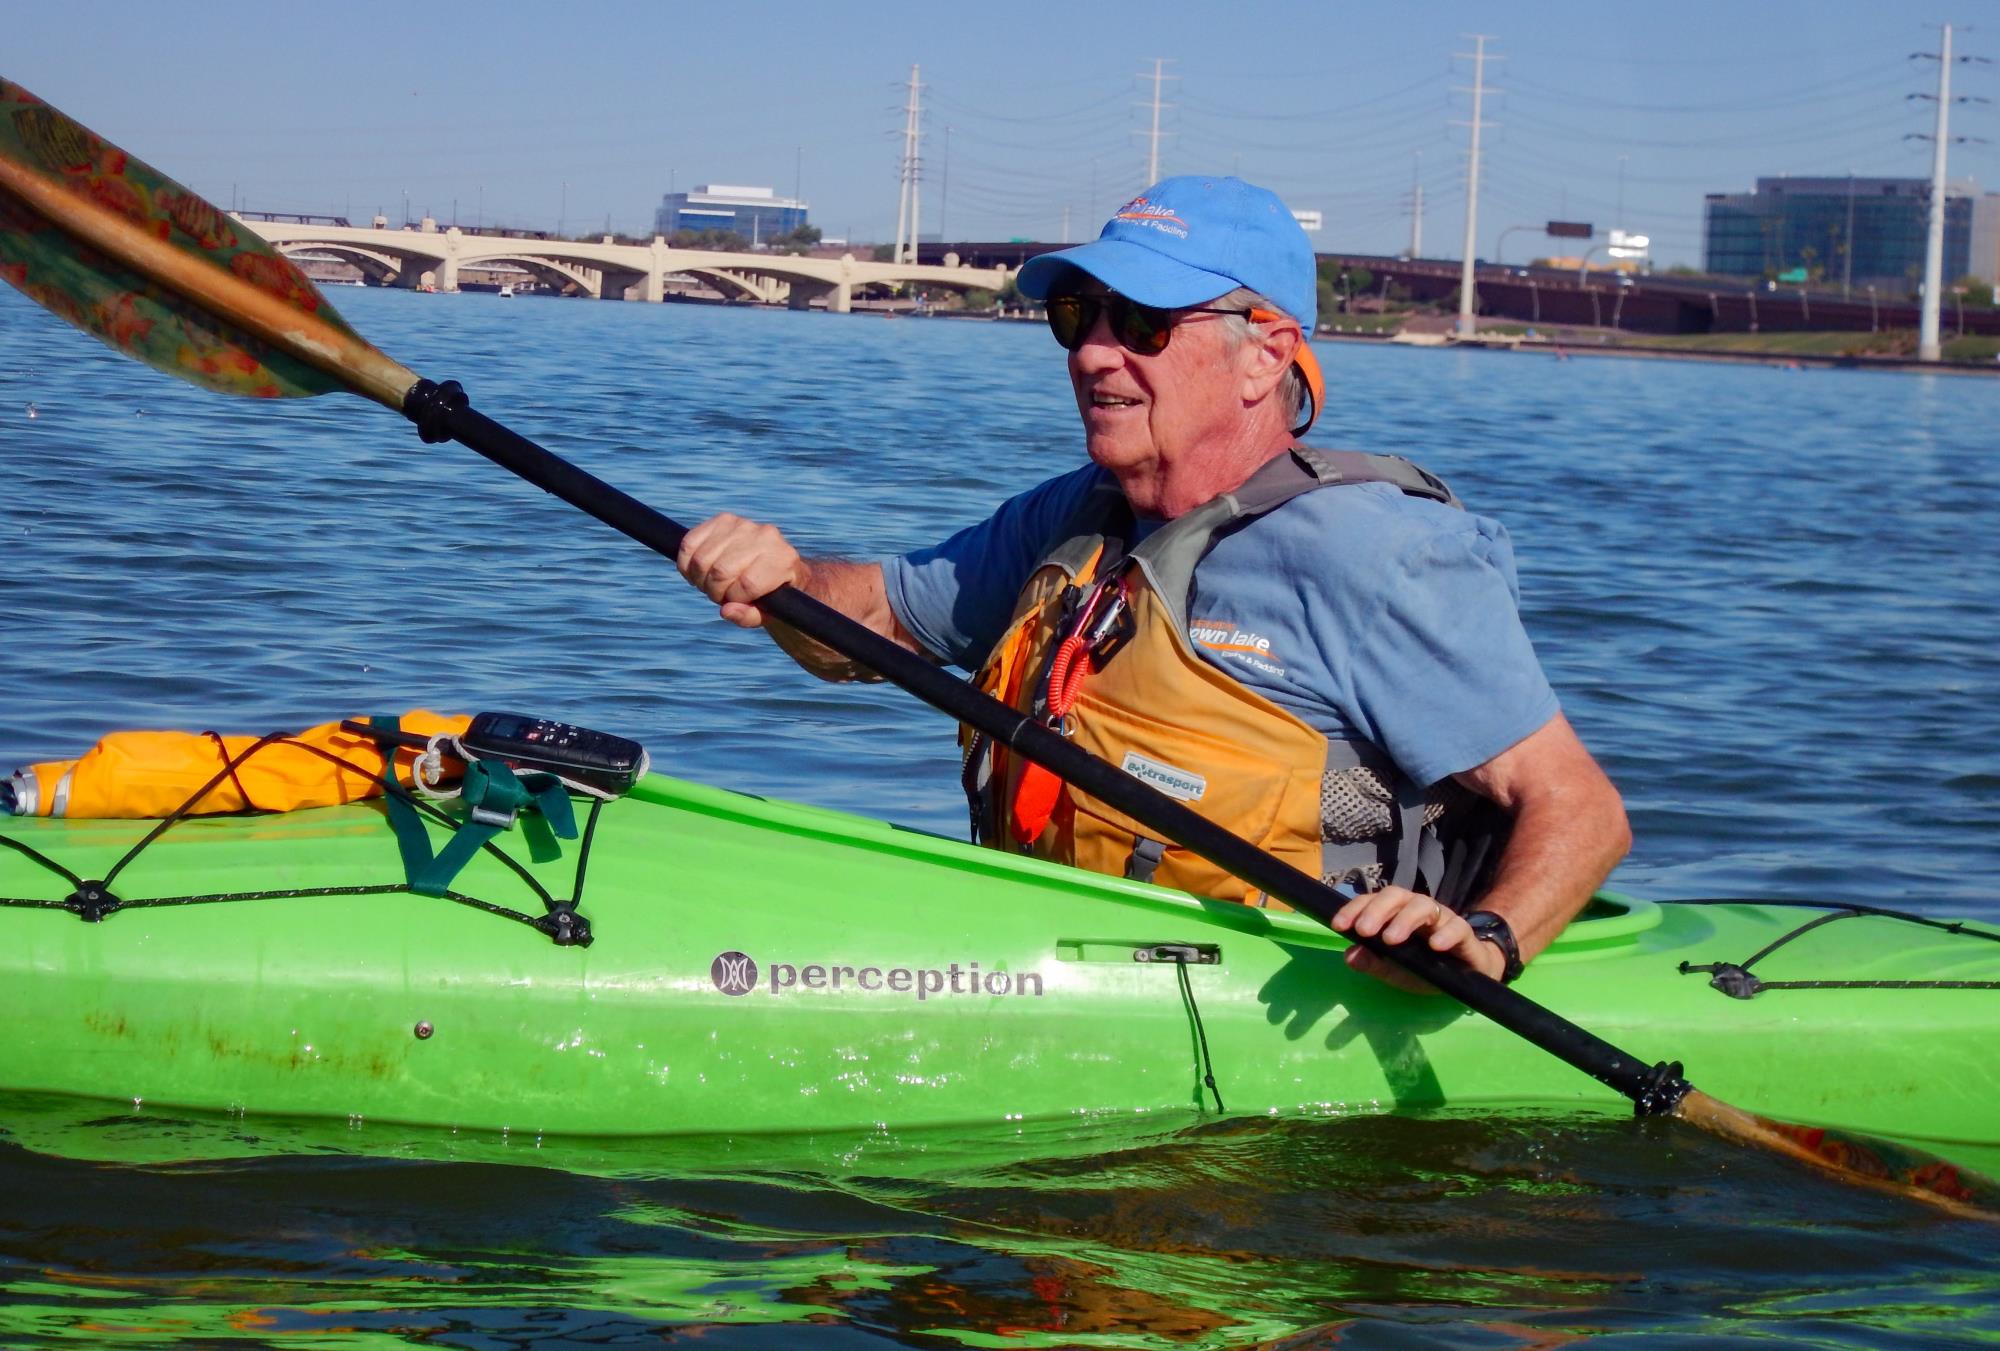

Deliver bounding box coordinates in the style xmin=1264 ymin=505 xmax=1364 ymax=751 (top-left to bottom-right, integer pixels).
xmin=0 ymin=71 xmax=2000 ymax=1219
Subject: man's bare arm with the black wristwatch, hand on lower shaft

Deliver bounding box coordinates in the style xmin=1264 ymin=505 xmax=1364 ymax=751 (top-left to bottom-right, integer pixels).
xmin=1334 ymin=713 xmax=1632 ymax=989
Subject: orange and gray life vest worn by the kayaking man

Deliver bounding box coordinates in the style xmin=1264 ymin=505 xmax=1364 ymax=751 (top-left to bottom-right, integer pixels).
xmin=960 ymin=446 xmax=1506 ymax=907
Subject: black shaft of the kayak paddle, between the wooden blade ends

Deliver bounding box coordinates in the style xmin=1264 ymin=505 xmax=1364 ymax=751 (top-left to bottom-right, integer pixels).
xmin=404 ymin=380 xmax=1688 ymax=1113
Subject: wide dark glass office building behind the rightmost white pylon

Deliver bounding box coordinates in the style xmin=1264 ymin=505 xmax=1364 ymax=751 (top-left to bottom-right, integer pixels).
xmin=1704 ymin=178 xmax=1976 ymax=294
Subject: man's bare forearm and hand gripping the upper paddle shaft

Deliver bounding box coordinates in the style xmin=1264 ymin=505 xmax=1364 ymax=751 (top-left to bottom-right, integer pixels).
xmin=674 ymin=512 xmax=928 ymax=679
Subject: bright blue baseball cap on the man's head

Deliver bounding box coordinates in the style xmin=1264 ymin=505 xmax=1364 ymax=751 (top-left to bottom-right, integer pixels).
xmin=1014 ymin=174 xmax=1320 ymax=336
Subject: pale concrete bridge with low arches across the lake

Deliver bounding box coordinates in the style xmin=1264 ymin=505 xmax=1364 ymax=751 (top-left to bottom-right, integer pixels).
xmin=236 ymin=216 xmax=1010 ymax=314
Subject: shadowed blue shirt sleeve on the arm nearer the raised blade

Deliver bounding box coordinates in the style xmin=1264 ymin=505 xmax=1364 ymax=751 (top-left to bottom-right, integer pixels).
xmin=882 ymin=466 xmax=1104 ymax=670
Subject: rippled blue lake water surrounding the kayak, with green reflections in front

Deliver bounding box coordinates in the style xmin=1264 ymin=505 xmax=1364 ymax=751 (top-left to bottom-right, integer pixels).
xmin=0 ymin=281 xmax=2000 ymax=1347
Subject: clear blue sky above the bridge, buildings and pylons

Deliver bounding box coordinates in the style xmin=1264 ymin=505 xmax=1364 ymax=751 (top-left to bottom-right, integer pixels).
xmin=11 ymin=0 xmax=2000 ymax=264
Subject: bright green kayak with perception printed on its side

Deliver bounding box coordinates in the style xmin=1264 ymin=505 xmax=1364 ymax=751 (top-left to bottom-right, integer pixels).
xmin=0 ymin=775 xmax=2000 ymax=1145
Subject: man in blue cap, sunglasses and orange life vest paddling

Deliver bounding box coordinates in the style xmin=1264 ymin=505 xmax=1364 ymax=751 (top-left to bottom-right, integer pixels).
xmin=678 ymin=178 xmax=1630 ymax=983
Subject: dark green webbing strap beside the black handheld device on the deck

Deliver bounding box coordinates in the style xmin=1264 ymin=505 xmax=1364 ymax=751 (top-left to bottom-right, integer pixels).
xmin=368 ymin=715 xmax=576 ymax=895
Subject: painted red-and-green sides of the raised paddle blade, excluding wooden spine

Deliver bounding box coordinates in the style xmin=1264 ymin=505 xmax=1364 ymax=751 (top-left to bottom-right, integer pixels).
xmin=0 ymin=78 xmax=358 ymax=398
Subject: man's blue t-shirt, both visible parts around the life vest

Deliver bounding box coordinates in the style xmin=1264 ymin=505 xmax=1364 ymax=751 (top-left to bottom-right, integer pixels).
xmin=882 ymin=466 xmax=1558 ymax=785
